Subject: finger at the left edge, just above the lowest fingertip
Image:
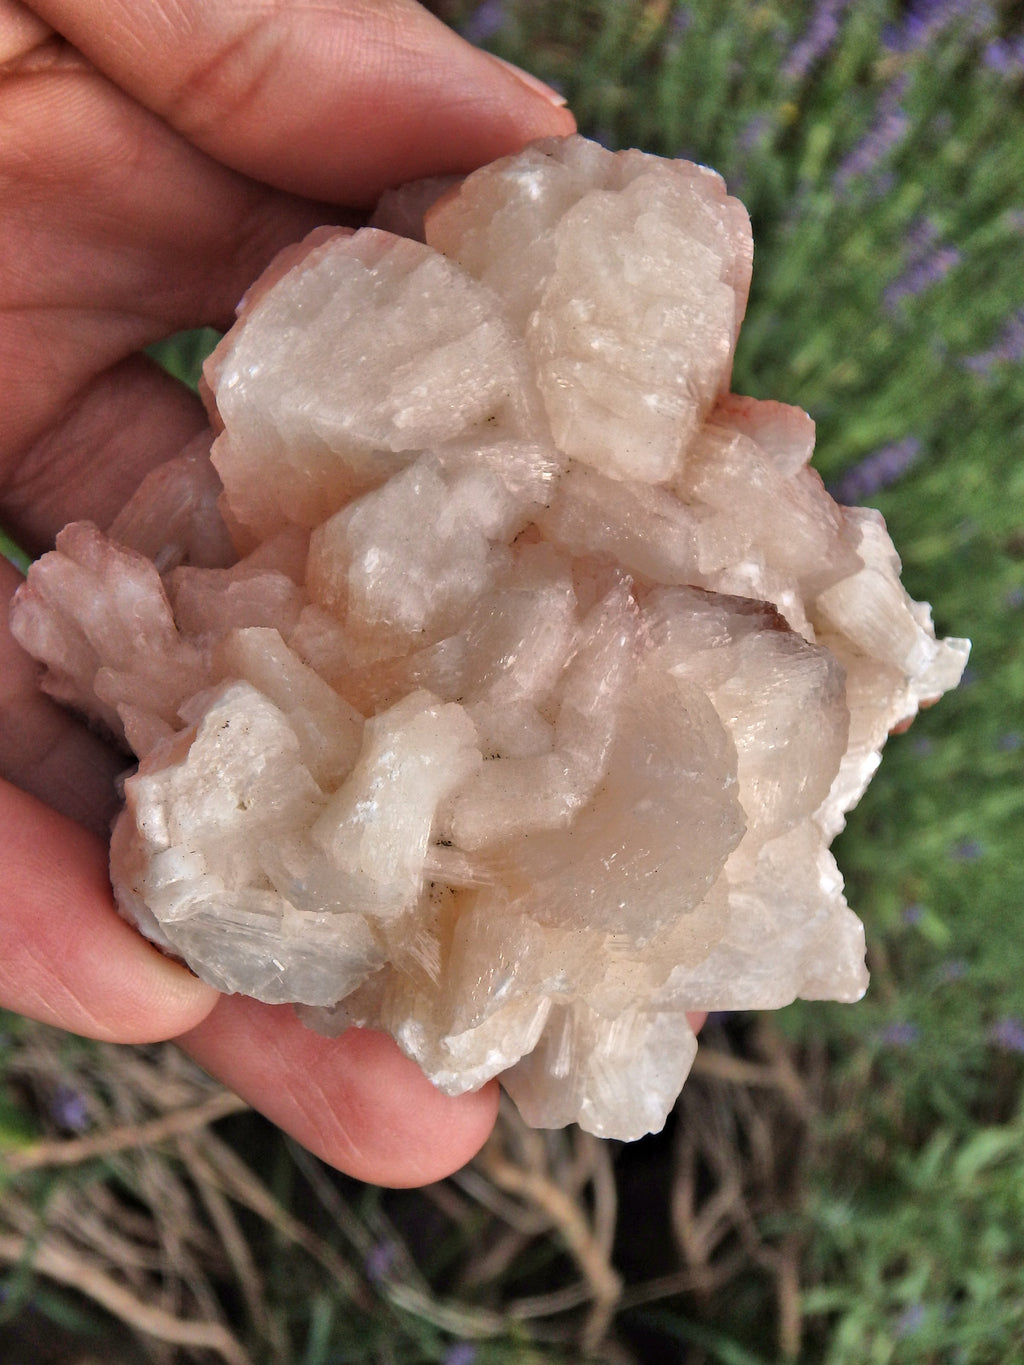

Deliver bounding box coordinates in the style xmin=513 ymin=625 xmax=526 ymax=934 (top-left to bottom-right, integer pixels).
xmin=0 ymin=782 xmax=217 ymax=1043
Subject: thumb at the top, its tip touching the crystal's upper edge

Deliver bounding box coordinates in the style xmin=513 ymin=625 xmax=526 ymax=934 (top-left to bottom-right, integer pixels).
xmin=33 ymin=0 xmax=575 ymax=205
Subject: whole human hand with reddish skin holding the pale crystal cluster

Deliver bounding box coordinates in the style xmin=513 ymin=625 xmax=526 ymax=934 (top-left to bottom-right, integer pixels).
xmin=0 ymin=0 xmax=573 ymax=1185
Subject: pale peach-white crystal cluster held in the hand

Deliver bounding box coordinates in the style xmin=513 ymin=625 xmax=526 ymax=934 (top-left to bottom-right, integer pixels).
xmin=14 ymin=138 xmax=968 ymax=1138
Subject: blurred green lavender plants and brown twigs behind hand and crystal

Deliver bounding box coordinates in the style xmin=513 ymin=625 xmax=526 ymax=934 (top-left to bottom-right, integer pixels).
xmin=0 ymin=0 xmax=1024 ymax=1365
